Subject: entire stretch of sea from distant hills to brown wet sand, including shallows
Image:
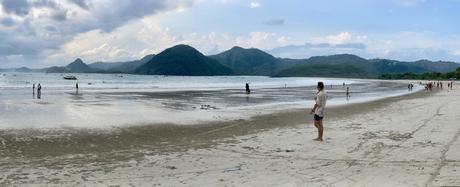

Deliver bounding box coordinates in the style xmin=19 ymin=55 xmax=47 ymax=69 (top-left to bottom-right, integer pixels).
xmin=0 ymin=73 xmax=421 ymax=129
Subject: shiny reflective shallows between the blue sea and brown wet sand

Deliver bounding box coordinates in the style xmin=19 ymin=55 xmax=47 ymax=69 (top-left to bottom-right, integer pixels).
xmin=0 ymin=78 xmax=416 ymax=130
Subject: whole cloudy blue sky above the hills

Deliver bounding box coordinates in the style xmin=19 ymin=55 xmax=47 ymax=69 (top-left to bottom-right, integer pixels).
xmin=0 ymin=0 xmax=460 ymax=68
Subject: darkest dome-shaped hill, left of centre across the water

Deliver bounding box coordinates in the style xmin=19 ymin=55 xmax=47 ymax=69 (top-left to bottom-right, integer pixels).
xmin=134 ymin=45 xmax=233 ymax=76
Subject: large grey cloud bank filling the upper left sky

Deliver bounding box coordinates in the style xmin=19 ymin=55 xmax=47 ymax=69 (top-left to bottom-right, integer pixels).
xmin=0 ymin=0 xmax=196 ymax=67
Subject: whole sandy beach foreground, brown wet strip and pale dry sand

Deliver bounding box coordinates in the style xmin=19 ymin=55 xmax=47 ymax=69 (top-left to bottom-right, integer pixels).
xmin=0 ymin=84 xmax=460 ymax=186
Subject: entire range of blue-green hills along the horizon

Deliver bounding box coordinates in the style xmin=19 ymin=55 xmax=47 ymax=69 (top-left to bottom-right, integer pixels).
xmin=0 ymin=44 xmax=460 ymax=79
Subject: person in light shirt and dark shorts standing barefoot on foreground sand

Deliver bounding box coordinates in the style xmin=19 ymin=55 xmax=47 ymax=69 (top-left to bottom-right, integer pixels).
xmin=310 ymin=82 xmax=327 ymax=141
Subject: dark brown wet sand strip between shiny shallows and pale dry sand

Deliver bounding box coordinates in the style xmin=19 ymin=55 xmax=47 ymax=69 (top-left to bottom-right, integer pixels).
xmin=0 ymin=85 xmax=430 ymax=157
